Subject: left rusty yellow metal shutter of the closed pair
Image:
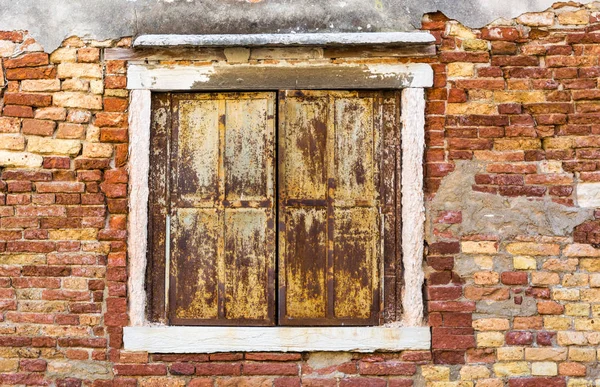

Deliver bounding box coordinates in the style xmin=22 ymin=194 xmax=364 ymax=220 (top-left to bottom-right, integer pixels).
xmin=167 ymin=93 xmax=275 ymax=325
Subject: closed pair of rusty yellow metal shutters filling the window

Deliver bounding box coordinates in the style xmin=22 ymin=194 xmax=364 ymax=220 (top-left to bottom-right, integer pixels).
xmin=146 ymin=90 xmax=401 ymax=326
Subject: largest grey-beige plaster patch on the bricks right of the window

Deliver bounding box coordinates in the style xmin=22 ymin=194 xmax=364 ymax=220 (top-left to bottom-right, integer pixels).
xmin=426 ymin=161 xmax=593 ymax=240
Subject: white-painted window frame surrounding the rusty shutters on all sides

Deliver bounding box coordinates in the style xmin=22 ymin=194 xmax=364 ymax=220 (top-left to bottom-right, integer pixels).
xmin=124 ymin=33 xmax=433 ymax=353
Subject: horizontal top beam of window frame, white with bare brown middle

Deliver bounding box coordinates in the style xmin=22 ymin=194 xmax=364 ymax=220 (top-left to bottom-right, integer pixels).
xmin=127 ymin=63 xmax=433 ymax=91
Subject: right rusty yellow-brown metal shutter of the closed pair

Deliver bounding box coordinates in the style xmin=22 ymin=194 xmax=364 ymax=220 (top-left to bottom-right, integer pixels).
xmin=278 ymin=91 xmax=397 ymax=325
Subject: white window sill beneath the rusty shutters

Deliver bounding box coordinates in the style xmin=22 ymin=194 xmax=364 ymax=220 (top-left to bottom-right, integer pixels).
xmin=123 ymin=326 xmax=431 ymax=353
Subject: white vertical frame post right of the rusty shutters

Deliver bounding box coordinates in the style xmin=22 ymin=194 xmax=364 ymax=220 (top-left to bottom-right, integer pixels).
xmin=400 ymin=89 xmax=425 ymax=326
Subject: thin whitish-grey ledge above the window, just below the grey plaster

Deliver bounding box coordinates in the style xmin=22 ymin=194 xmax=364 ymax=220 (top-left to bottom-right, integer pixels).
xmin=133 ymin=31 xmax=435 ymax=47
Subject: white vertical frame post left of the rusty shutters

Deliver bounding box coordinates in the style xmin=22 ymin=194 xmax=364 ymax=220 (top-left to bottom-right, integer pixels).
xmin=127 ymin=90 xmax=151 ymax=326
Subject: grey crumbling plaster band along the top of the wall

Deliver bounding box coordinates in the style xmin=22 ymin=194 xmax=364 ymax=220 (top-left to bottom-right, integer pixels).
xmin=0 ymin=0 xmax=589 ymax=52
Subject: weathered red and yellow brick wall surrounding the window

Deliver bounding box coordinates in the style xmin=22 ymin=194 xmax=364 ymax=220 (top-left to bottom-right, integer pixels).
xmin=0 ymin=3 xmax=600 ymax=387
